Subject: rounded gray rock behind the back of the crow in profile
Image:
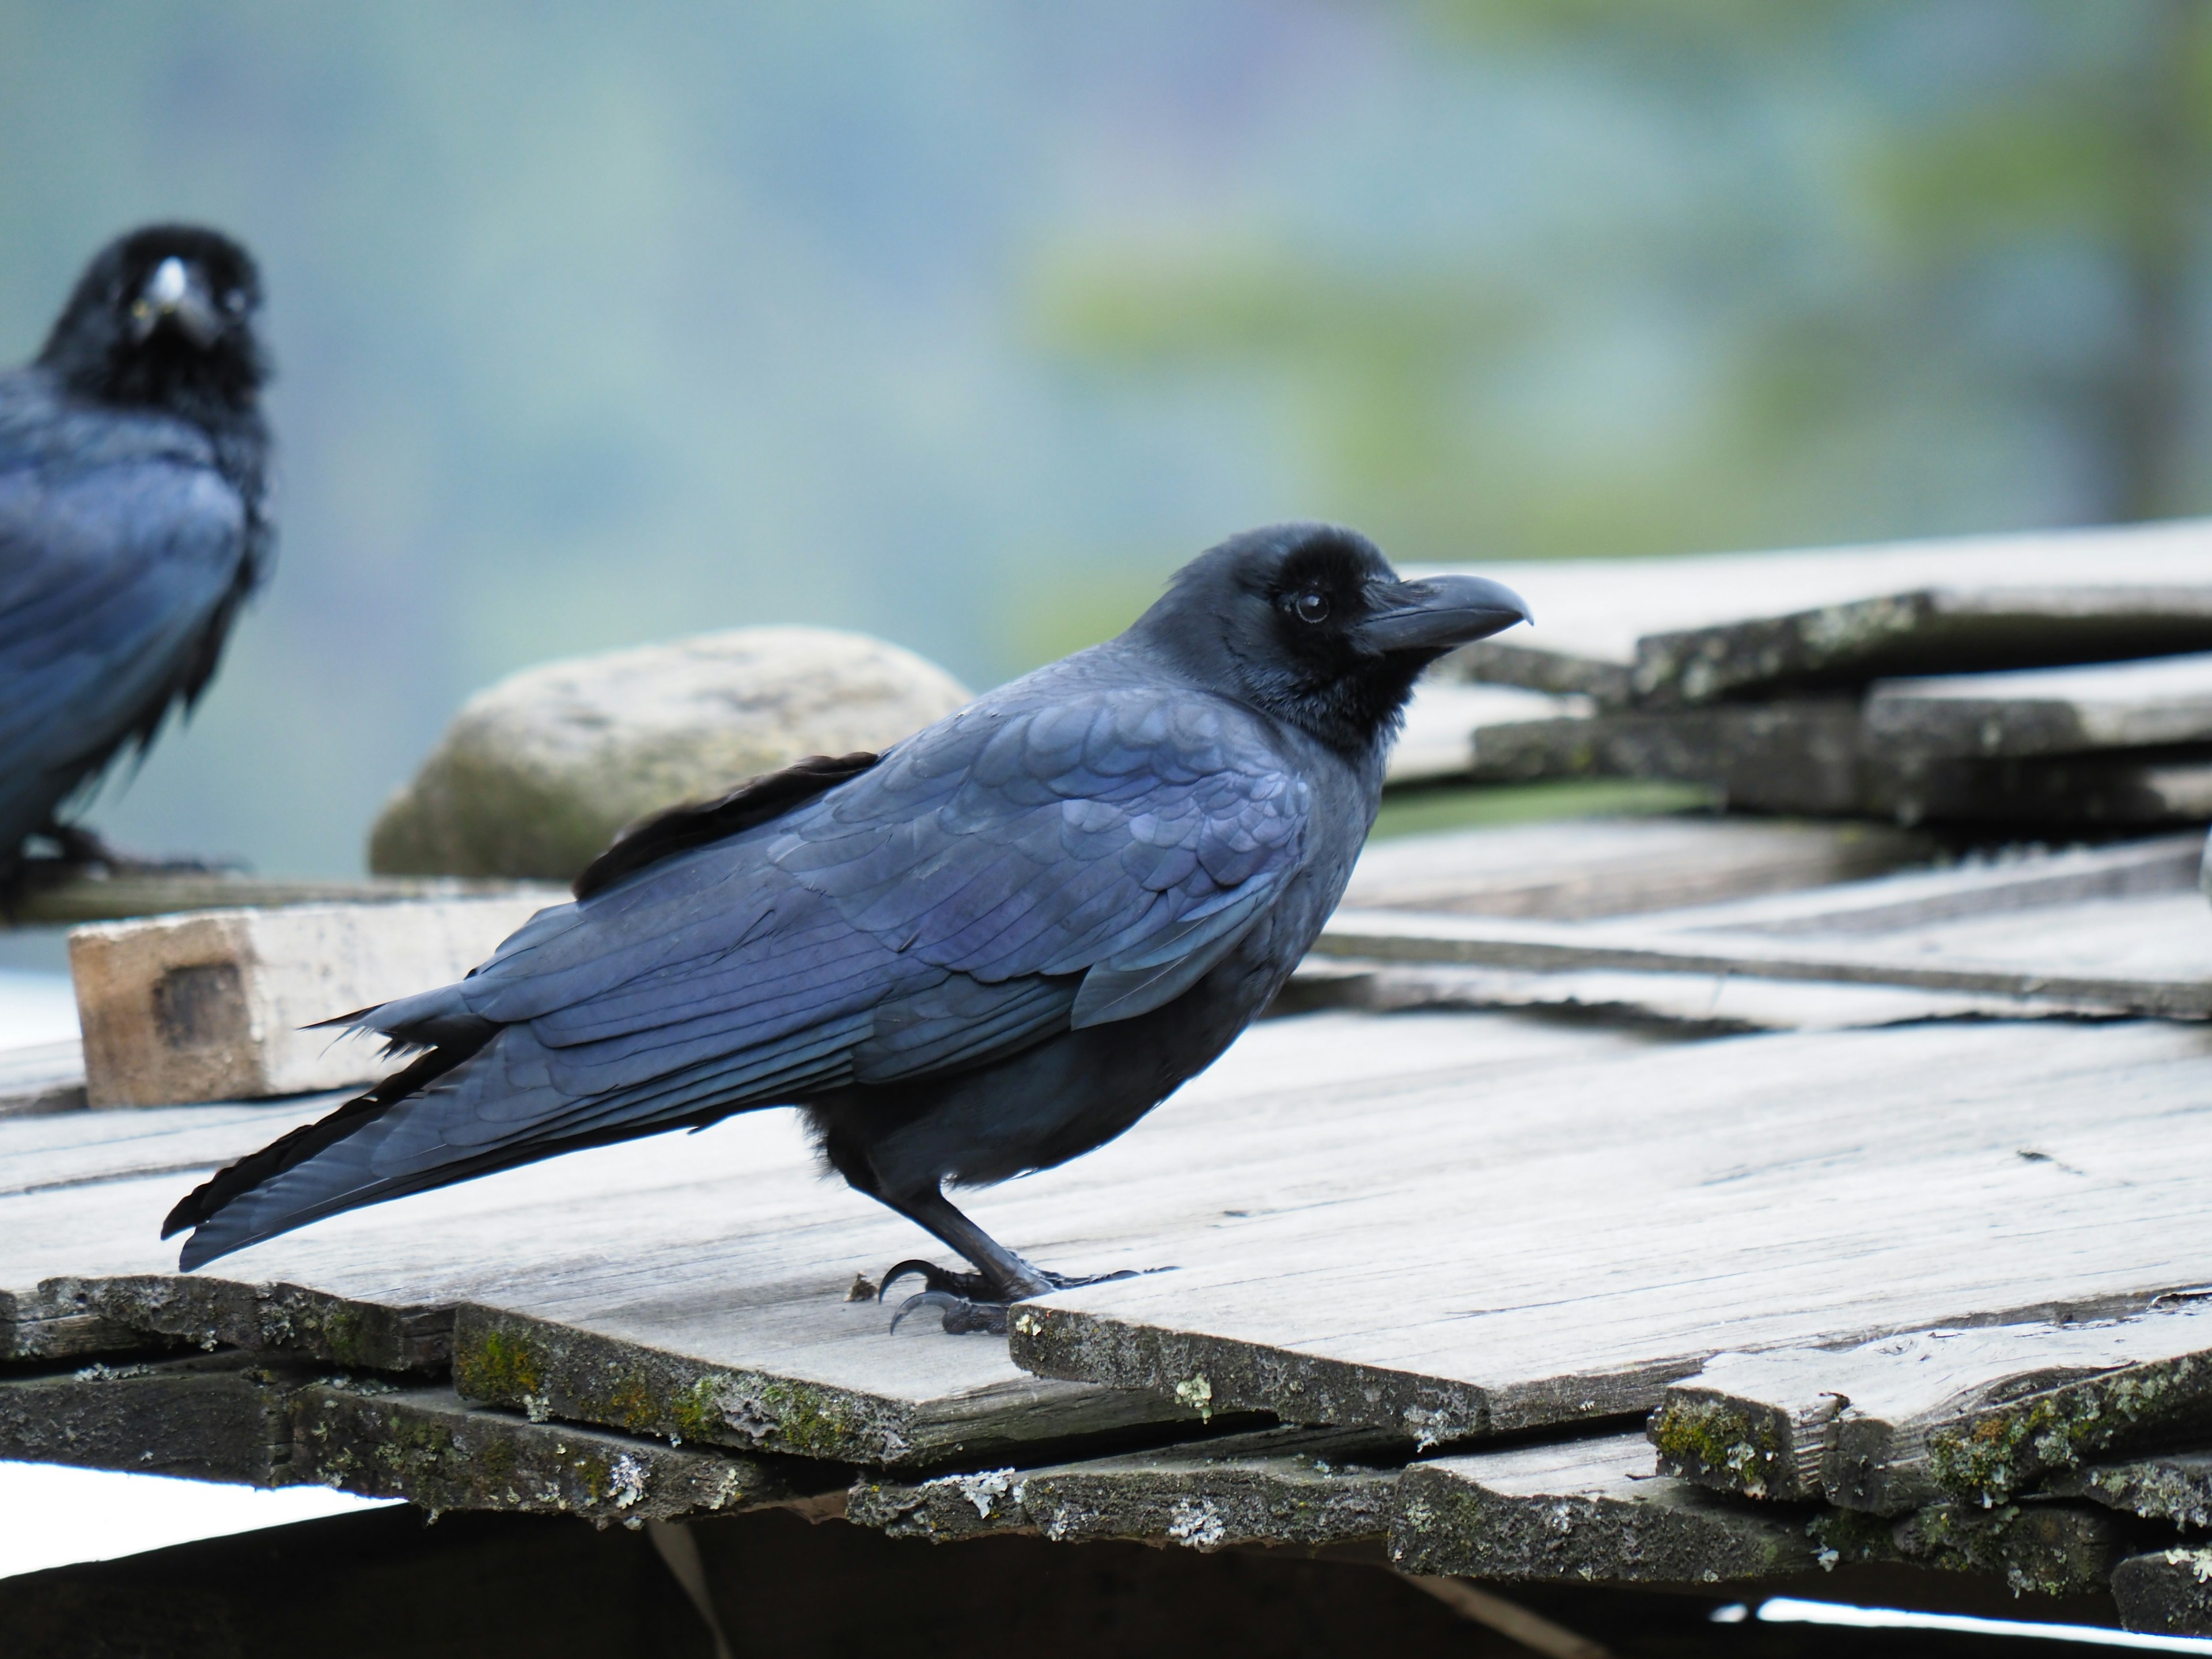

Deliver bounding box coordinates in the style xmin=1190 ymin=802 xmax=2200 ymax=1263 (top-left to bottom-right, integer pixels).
xmin=369 ymin=628 xmax=969 ymax=880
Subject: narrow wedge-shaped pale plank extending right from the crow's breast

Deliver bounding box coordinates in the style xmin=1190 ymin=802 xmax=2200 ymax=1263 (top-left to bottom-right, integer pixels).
xmin=1314 ymin=836 xmax=2212 ymax=1020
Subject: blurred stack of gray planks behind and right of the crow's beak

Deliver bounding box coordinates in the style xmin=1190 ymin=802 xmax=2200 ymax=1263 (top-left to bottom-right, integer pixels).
xmin=1397 ymin=522 xmax=2212 ymax=830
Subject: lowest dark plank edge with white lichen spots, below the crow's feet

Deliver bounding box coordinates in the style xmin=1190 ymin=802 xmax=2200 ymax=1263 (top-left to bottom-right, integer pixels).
xmin=845 ymin=1429 xmax=1404 ymax=1551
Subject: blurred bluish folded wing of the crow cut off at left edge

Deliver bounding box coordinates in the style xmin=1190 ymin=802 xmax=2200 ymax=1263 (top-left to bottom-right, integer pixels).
xmin=0 ymin=425 xmax=248 ymax=845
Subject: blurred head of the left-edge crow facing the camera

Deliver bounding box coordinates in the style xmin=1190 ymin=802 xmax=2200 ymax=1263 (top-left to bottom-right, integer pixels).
xmin=37 ymin=226 xmax=268 ymax=425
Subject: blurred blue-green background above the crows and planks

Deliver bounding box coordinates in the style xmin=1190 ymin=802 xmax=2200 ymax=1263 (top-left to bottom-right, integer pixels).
xmin=0 ymin=0 xmax=2212 ymax=874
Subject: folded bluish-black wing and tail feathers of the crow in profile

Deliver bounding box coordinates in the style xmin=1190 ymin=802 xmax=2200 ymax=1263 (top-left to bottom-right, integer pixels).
xmin=175 ymin=672 xmax=1307 ymax=1265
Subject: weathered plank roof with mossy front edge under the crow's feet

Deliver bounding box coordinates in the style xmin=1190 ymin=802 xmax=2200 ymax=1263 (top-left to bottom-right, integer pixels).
xmin=0 ymin=819 xmax=2212 ymax=1630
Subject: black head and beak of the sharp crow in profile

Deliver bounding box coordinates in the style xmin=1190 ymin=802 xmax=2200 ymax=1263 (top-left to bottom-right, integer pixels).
xmin=1130 ymin=524 xmax=1531 ymax=750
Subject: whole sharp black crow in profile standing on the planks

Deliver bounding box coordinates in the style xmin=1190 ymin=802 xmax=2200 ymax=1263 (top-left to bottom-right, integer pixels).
xmin=161 ymin=524 xmax=1528 ymax=1330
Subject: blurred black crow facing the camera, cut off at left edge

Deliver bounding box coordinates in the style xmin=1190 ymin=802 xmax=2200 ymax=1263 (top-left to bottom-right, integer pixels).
xmin=0 ymin=226 xmax=274 ymax=892
